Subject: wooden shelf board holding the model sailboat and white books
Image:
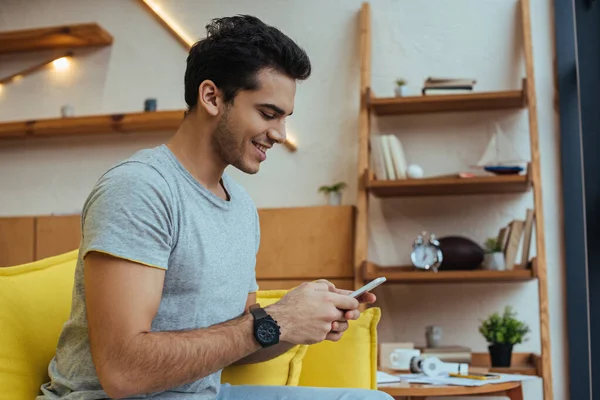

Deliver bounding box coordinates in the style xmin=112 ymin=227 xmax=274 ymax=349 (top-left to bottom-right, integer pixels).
xmin=367 ymin=174 xmax=531 ymax=197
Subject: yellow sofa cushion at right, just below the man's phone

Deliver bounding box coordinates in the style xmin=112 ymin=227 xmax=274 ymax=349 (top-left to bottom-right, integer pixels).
xmin=299 ymin=307 xmax=381 ymax=389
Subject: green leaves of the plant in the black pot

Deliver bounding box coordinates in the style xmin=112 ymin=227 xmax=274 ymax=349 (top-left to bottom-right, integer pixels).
xmin=479 ymin=306 xmax=530 ymax=345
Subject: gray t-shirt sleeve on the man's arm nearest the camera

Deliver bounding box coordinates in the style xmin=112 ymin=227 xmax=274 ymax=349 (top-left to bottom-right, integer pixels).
xmin=82 ymin=162 xmax=174 ymax=270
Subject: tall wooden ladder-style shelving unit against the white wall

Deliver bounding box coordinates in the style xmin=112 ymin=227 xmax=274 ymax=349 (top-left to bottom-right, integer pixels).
xmin=354 ymin=0 xmax=553 ymax=400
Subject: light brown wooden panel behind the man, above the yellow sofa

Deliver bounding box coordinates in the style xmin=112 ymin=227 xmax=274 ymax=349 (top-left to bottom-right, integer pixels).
xmin=0 ymin=206 xmax=354 ymax=289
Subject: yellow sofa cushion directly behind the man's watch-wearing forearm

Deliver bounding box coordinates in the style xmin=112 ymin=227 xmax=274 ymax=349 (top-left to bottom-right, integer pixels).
xmin=221 ymin=290 xmax=308 ymax=386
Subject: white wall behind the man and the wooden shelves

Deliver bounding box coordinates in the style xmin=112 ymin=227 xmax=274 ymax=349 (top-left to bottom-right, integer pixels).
xmin=0 ymin=0 xmax=568 ymax=399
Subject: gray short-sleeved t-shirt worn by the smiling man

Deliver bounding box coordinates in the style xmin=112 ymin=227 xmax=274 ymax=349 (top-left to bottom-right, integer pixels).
xmin=38 ymin=145 xmax=260 ymax=400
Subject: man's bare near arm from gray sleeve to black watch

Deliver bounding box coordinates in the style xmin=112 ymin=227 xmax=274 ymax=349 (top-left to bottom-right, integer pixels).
xmin=84 ymin=252 xmax=260 ymax=398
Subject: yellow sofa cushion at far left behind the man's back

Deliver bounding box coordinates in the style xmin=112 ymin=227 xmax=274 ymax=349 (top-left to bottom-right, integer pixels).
xmin=0 ymin=251 xmax=78 ymax=400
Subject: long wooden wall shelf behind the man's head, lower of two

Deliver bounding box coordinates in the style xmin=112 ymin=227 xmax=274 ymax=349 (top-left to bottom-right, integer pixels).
xmin=0 ymin=110 xmax=297 ymax=151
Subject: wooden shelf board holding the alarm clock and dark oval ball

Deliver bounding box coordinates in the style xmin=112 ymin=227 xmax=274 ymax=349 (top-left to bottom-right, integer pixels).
xmin=363 ymin=262 xmax=534 ymax=283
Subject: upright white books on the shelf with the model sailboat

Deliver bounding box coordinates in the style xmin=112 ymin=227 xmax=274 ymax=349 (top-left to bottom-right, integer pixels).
xmin=369 ymin=135 xmax=408 ymax=180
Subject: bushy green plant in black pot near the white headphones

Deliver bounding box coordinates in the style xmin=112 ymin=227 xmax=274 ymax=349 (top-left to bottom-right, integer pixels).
xmin=479 ymin=306 xmax=529 ymax=367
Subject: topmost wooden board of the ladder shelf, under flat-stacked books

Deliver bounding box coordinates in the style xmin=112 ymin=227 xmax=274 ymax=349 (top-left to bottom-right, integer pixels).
xmin=369 ymin=86 xmax=527 ymax=115
